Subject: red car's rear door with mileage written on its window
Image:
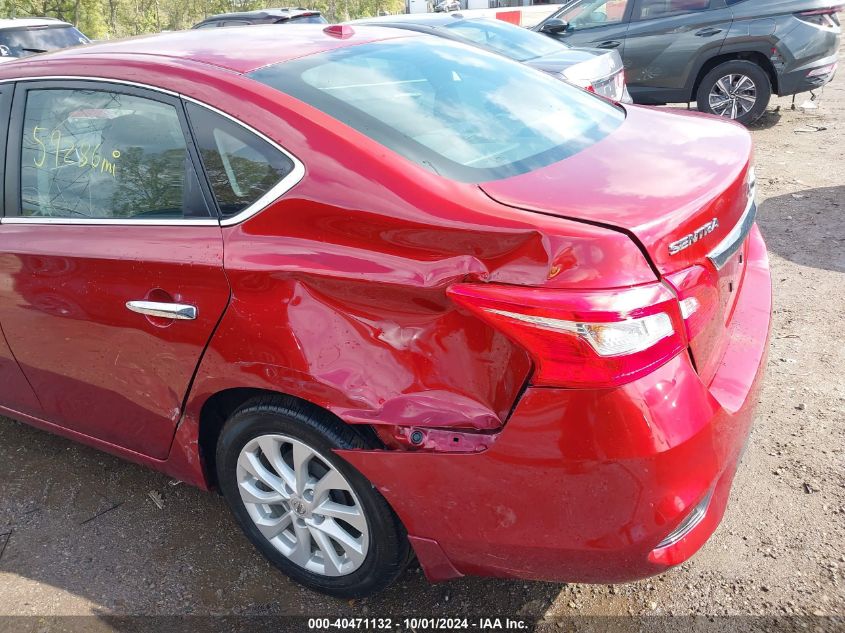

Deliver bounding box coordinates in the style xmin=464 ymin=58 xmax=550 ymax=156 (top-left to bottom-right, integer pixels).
xmin=0 ymin=81 xmax=229 ymax=458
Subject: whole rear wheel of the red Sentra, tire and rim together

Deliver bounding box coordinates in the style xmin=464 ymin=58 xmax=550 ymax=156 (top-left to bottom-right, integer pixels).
xmin=217 ymin=396 xmax=411 ymax=599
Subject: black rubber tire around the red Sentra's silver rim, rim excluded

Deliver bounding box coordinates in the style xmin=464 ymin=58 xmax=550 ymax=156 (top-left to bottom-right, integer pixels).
xmin=217 ymin=410 xmax=407 ymax=598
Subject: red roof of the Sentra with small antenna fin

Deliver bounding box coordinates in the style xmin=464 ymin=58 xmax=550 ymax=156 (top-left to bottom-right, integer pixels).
xmin=5 ymin=24 xmax=416 ymax=73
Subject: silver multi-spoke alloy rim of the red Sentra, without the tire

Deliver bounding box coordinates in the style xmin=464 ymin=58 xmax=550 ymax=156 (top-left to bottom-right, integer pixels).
xmin=237 ymin=434 xmax=370 ymax=576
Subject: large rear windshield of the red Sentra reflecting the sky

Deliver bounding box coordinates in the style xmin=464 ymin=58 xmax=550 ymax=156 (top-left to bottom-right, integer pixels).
xmin=250 ymin=36 xmax=625 ymax=182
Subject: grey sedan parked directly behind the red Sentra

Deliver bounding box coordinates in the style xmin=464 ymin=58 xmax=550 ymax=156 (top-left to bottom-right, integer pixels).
xmin=353 ymin=13 xmax=631 ymax=103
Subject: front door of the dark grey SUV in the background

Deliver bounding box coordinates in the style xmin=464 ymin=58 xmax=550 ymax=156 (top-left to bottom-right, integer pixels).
xmin=550 ymin=0 xmax=634 ymax=55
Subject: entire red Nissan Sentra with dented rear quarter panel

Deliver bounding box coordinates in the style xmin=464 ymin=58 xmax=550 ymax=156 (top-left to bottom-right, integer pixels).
xmin=0 ymin=25 xmax=771 ymax=597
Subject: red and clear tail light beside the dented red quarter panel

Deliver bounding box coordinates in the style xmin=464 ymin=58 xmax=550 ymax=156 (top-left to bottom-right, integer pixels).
xmin=448 ymin=283 xmax=686 ymax=387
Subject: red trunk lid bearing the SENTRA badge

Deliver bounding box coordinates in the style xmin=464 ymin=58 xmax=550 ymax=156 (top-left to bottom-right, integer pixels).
xmin=480 ymin=106 xmax=752 ymax=275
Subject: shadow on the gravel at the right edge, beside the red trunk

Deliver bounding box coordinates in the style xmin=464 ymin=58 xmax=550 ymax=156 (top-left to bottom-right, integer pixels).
xmin=757 ymin=186 xmax=845 ymax=272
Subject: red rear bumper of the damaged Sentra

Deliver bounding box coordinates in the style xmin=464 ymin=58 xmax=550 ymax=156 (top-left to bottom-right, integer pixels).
xmin=341 ymin=227 xmax=771 ymax=583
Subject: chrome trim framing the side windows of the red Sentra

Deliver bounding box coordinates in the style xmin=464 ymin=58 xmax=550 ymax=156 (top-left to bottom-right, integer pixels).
xmin=0 ymin=75 xmax=305 ymax=226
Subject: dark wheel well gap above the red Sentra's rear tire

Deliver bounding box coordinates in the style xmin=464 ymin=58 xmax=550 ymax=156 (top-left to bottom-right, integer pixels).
xmin=198 ymin=387 xmax=383 ymax=488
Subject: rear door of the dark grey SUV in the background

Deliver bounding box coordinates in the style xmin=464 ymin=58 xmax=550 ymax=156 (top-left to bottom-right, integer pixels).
xmin=622 ymin=0 xmax=733 ymax=103
